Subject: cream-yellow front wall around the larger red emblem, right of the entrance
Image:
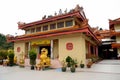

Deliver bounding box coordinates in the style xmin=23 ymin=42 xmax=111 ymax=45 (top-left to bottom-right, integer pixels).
xmin=59 ymin=35 xmax=86 ymax=64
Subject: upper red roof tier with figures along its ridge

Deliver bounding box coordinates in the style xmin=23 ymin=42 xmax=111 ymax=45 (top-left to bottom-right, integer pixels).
xmin=18 ymin=5 xmax=86 ymax=29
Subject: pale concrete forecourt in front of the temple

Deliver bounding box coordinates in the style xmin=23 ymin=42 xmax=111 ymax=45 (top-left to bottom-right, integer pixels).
xmin=0 ymin=60 xmax=120 ymax=80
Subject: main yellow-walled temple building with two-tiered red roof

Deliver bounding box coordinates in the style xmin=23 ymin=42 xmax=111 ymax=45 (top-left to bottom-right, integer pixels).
xmin=8 ymin=5 xmax=100 ymax=63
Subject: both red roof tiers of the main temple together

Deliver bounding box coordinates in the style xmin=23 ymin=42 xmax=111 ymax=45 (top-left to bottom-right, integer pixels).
xmin=7 ymin=5 xmax=99 ymax=43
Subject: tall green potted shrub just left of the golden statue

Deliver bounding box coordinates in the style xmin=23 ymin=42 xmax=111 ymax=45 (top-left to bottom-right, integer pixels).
xmin=29 ymin=49 xmax=37 ymax=70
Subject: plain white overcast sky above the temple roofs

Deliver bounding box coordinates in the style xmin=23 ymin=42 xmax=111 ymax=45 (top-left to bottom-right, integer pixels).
xmin=0 ymin=0 xmax=120 ymax=35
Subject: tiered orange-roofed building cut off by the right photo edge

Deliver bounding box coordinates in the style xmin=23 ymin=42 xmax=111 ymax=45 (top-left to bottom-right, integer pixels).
xmin=109 ymin=18 xmax=120 ymax=58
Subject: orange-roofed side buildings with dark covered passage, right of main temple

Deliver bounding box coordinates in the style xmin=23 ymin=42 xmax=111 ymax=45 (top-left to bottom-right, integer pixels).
xmin=92 ymin=18 xmax=120 ymax=59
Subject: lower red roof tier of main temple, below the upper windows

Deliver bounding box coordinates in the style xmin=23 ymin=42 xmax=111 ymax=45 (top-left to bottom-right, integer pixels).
xmin=7 ymin=26 xmax=100 ymax=43
